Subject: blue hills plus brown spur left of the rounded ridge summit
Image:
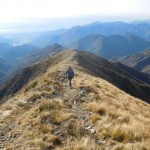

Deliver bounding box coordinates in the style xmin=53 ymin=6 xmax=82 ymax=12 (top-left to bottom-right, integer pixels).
xmin=0 ymin=44 xmax=64 ymax=83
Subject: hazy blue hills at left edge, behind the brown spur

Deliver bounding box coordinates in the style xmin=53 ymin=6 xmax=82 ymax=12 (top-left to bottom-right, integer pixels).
xmin=0 ymin=43 xmax=39 ymax=82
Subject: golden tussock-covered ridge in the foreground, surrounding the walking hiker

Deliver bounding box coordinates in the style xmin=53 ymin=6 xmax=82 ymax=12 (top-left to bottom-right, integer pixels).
xmin=0 ymin=50 xmax=150 ymax=150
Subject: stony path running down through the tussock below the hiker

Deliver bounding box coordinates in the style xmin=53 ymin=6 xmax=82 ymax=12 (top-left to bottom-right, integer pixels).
xmin=54 ymin=75 xmax=110 ymax=150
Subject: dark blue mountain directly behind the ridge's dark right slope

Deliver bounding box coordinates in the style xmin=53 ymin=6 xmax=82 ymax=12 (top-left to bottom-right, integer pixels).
xmin=70 ymin=34 xmax=150 ymax=59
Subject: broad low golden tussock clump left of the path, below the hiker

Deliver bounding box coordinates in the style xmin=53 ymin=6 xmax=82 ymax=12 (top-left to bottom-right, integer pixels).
xmin=39 ymin=100 xmax=63 ymax=112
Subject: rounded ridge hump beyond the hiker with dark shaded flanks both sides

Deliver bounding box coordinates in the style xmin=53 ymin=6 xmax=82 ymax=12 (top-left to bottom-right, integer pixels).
xmin=0 ymin=50 xmax=150 ymax=102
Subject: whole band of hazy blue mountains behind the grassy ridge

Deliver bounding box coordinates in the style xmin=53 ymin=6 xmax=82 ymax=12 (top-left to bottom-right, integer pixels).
xmin=0 ymin=22 xmax=150 ymax=82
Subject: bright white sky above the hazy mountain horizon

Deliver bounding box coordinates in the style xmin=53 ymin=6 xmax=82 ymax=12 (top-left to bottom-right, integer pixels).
xmin=0 ymin=0 xmax=150 ymax=30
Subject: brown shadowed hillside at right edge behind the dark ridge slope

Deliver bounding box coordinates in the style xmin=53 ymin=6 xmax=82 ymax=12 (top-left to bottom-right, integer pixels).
xmin=112 ymin=48 xmax=150 ymax=74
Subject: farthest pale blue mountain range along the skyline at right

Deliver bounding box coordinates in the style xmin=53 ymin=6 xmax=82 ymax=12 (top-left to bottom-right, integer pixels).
xmin=33 ymin=22 xmax=150 ymax=47
